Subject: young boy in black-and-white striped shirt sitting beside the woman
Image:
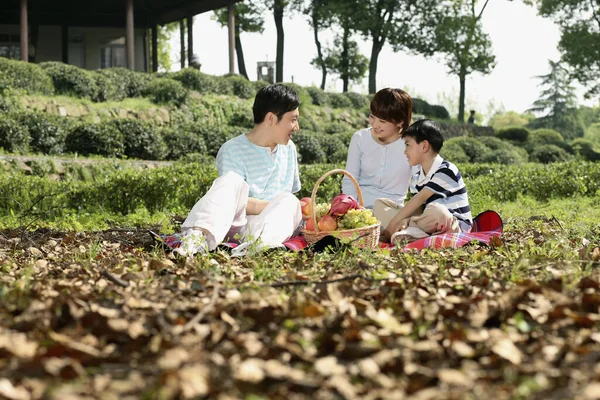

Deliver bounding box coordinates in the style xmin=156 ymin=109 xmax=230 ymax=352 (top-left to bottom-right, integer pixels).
xmin=381 ymin=119 xmax=473 ymax=243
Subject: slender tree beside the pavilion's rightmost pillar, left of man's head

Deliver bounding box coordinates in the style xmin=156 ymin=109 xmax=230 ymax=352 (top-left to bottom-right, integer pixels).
xmin=214 ymin=0 xmax=265 ymax=79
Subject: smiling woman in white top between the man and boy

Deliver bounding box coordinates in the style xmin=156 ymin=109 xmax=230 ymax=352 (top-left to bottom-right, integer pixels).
xmin=342 ymin=88 xmax=412 ymax=229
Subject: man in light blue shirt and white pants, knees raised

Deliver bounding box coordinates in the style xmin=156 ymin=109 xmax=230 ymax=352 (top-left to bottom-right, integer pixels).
xmin=175 ymin=84 xmax=302 ymax=255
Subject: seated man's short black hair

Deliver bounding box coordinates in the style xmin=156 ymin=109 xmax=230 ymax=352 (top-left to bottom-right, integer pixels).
xmin=252 ymin=83 xmax=300 ymax=124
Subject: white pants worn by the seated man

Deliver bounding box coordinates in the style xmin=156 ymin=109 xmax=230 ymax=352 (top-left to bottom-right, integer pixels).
xmin=181 ymin=172 xmax=302 ymax=250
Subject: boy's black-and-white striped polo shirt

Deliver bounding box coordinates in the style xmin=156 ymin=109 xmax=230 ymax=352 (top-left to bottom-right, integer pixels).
xmin=413 ymin=155 xmax=473 ymax=232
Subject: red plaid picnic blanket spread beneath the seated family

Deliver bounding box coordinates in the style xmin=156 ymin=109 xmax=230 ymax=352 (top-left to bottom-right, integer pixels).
xmin=150 ymin=210 xmax=503 ymax=251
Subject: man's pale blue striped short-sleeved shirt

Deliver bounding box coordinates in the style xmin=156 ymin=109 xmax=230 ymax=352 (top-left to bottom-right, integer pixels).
xmin=217 ymin=134 xmax=300 ymax=200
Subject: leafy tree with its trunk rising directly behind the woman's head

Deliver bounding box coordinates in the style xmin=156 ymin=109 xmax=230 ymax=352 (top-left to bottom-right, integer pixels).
xmin=354 ymin=0 xmax=439 ymax=93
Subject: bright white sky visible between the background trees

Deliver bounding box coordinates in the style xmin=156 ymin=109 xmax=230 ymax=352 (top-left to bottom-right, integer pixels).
xmin=171 ymin=0 xmax=598 ymax=119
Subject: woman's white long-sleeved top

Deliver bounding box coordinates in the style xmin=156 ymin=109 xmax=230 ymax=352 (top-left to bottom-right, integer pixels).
xmin=342 ymin=128 xmax=412 ymax=208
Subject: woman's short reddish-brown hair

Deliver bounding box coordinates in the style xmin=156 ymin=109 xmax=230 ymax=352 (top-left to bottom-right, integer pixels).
xmin=370 ymin=88 xmax=412 ymax=129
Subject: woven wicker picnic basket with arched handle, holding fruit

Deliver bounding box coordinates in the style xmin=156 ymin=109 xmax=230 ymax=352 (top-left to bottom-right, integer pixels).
xmin=302 ymin=169 xmax=381 ymax=249
